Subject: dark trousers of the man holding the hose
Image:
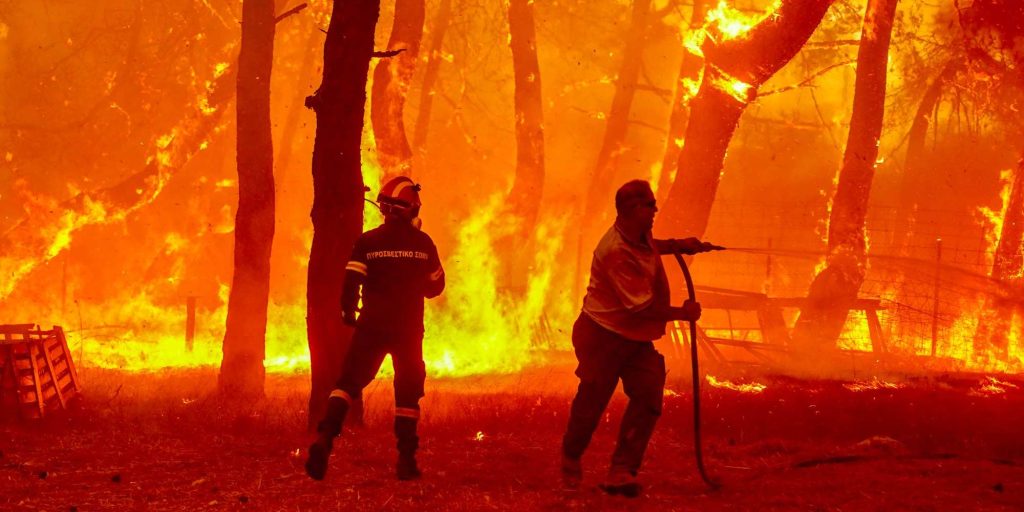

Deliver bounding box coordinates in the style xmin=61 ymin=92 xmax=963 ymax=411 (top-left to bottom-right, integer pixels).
xmin=562 ymin=313 xmax=665 ymax=475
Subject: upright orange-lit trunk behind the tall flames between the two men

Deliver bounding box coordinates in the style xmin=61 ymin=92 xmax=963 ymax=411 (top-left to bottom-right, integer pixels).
xmin=505 ymin=0 xmax=544 ymax=285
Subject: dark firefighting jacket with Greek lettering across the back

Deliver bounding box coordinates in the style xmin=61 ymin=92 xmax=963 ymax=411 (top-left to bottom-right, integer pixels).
xmin=341 ymin=220 xmax=444 ymax=330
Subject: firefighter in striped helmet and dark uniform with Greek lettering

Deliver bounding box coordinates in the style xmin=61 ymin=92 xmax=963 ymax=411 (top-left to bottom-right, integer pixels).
xmin=306 ymin=176 xmax=444 ymax=480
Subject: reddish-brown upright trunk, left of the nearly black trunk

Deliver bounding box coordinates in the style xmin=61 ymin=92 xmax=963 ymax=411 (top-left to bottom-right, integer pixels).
xmin=218 ymin=0 xmax=274 ymax=396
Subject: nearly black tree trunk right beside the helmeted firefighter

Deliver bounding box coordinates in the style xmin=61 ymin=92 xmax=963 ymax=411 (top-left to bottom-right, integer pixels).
xmin=306 ymin=0 xmax=380 ymax=425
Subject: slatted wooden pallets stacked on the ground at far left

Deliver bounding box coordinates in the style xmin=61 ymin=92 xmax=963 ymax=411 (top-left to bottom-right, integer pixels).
xmin=0 ymin=324 xmax=82 ymax=418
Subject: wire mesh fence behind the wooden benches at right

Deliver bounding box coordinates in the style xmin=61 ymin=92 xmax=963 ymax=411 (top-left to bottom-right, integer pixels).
xmin=693 ymin=201 xmax=1020 ymax=367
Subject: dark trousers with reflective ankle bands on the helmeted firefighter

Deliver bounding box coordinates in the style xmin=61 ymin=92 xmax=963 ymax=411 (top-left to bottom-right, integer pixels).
xmin=318 ymin=323 xmax=427 ymax=454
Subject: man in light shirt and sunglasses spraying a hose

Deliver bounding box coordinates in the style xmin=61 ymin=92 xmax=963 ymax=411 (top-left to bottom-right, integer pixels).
xmin=561 ymin=180 xmax=714 ymax=497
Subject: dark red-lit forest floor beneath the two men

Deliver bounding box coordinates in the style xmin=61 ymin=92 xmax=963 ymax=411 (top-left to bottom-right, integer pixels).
xmin=0 ymin=365 xmax=1024 ymax=511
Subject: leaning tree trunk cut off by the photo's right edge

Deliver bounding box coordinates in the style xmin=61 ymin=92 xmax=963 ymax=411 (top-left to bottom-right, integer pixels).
xmin=974 ymin=154 xmax=1024 ymax=360
